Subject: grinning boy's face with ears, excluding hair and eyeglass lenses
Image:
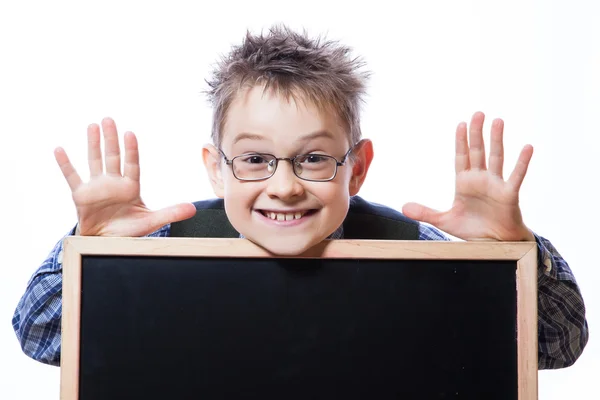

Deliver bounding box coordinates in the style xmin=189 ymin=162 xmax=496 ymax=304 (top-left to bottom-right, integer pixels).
xmin=203 ymin=87 xmax=373 ymax=255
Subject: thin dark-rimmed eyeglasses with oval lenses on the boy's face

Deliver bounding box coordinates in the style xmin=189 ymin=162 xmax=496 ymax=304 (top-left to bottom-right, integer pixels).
xmin=219 ymin=146 xmax=355 ymax=182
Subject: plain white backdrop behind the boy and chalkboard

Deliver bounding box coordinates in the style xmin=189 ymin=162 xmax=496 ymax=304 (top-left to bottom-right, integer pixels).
xmin=0 ymin=0 xmax=600 ymax=400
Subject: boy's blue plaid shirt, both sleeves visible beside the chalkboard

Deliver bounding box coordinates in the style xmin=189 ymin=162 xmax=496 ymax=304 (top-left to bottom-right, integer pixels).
xmin=12 ymin=220 xmax=588 ymax=369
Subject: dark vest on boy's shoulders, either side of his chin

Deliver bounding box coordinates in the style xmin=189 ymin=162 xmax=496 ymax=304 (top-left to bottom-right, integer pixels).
xmin=171 ymin=196 xmax=419 ymax=240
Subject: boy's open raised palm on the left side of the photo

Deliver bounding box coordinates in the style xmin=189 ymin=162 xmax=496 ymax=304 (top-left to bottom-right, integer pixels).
xmin=54 ymin=118 xmax=196 ymax=236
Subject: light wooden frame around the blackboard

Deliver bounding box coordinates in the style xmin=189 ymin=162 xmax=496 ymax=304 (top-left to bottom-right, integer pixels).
xmin=60 ymin=236 xmax=538 ymax=400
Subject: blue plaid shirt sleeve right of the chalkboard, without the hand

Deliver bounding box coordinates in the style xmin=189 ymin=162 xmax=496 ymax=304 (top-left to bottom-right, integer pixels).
xmin=419 ymin=224 xmax=589 ymax=369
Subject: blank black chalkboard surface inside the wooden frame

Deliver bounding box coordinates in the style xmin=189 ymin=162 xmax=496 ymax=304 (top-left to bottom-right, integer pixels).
xmin=79 ymin=255 xmax=517 ymax=400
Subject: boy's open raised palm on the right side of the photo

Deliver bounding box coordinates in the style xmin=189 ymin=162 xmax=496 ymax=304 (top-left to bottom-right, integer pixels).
xmin=402 ymin=112 xmax=535 ymax=241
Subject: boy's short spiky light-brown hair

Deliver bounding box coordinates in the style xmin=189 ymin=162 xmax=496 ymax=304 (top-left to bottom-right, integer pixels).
xmin=207 ymin=25 xmax=369 ymax=146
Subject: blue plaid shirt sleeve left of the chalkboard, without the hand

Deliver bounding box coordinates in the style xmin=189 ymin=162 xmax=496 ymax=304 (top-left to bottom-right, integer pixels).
xmin=12 ymin=225 xmax=170 ymax=366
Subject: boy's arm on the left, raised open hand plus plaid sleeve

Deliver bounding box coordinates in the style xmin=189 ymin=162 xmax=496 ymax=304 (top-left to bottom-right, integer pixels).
xmin=12 ymin=118 xmax=196 ymax=365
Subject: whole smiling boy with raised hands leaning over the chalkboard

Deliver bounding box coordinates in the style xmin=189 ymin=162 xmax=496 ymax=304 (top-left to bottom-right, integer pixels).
xmin=13 ymin=28 xmax=588 ymax=369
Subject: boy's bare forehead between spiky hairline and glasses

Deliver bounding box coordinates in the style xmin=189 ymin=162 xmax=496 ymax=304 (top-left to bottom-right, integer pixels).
xmin=221 ymin=86 xmax=349 ymax=145
